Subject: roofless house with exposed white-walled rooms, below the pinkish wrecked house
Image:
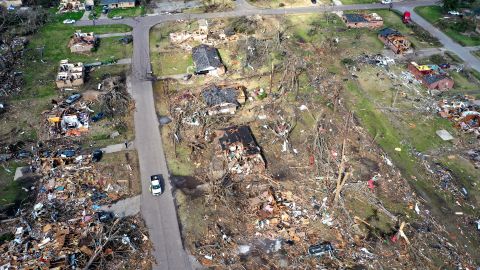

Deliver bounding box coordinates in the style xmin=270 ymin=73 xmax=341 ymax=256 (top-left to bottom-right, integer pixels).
xmin=55 ymin=60 xmax=85 ymax=88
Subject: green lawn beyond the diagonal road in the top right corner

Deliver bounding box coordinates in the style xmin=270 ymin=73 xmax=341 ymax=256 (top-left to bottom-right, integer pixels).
xmin=414 ymin=6 xmax=480 ymax=46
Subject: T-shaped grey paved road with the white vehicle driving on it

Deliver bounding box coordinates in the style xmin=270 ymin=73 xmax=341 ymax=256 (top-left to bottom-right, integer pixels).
xmin=77 ymin=0 xmax=450 ymax=270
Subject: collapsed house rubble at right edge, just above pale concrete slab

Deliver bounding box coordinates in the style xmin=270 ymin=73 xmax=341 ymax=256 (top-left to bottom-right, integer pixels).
xmin=437 ymin=96 xmax=480 ymax=136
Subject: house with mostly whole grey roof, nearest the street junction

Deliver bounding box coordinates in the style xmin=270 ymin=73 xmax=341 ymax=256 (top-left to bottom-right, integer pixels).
xmin=192 ymin=44 xmax=225 ymax=76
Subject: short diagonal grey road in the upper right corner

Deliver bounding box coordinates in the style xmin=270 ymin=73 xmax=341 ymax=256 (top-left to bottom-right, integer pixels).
xmin=396 ymin=6 xmax=480 ymax=71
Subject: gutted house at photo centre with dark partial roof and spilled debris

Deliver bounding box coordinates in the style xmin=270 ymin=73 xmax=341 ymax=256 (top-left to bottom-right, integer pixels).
xmin=215 ymin=126 xmax=266 ymax=175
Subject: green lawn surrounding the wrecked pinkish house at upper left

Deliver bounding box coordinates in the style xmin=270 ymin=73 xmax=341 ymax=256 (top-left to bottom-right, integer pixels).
xmin=21 ymin=18 xmax=132 ymax=98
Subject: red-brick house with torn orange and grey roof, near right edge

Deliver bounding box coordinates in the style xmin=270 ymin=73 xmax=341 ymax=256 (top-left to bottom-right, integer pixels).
xmin=408 ymin=62 xmax=454 ymax=91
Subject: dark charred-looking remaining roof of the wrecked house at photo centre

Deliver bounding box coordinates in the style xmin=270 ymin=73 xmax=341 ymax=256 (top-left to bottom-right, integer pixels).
xmin=218 ymin=126 xmax=260 ymax=155
